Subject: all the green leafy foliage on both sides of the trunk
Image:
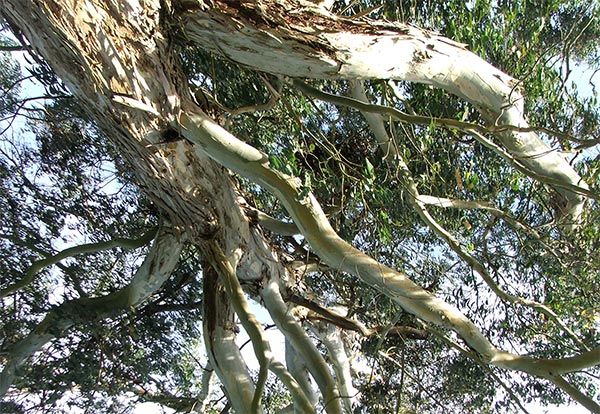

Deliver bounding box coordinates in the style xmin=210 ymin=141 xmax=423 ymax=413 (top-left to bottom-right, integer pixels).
xmin=0 ymin=0 xmax=600 ymax=413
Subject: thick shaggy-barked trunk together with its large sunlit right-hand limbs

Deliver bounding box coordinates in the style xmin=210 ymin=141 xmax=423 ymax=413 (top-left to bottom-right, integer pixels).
xmin=0 ymin=0 xmax=599 ymax=412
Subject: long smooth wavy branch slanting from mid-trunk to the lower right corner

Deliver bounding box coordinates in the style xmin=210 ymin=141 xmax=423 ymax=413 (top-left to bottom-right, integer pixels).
xmin=180 ymin=104 xmax=591 ymax=408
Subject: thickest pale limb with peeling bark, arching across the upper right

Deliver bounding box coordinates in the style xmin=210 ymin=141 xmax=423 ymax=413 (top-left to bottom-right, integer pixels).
xmin=184 ymin=0 xmax=588 ymax=229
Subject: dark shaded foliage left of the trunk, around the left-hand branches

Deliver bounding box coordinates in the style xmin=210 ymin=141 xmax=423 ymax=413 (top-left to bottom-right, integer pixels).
xmin=0 ymin=64 xmax=202 ymax=412
